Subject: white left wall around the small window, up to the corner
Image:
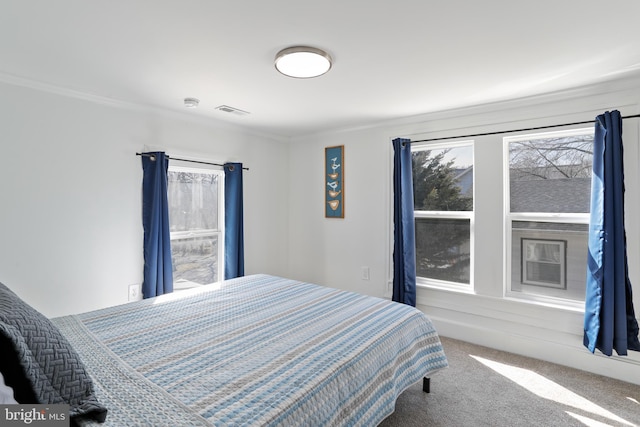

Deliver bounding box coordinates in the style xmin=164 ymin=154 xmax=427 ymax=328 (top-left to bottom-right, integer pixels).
xmin=0 ymin=84 xmax=289 ymax=316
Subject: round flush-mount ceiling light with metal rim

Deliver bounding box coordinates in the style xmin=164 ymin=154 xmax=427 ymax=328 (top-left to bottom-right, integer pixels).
xmin=275 ymin=46 xmax=331 ymax=79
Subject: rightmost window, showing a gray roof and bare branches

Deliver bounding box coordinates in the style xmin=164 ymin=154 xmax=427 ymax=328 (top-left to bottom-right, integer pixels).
xmin=504 ymin=129 xmax=593 ymax=304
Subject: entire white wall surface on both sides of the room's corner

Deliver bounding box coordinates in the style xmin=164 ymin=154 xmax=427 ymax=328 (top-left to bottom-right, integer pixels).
xmin=0 ymin=72 xmax=640 ymax=383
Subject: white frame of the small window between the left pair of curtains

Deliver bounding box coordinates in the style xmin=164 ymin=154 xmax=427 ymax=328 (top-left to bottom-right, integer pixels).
xmin=167 ymin=164 xmax=225 ymax=286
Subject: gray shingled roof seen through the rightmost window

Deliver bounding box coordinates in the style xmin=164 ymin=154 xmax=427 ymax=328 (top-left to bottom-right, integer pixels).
xmin=510 ymin=178 xmax=591 ymax=213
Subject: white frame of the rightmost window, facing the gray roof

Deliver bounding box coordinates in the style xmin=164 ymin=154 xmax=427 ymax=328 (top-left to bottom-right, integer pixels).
xmin=502 ymin=127 xmax=594 ymax=310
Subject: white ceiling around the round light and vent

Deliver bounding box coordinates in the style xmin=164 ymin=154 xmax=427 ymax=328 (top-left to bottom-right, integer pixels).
xmin=0 ymin=0 xmax=640 ymax=137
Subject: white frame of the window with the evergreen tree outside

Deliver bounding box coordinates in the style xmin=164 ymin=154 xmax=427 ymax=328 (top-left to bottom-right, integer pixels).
xmin=411 ymin=139 xmax=476 ymax=292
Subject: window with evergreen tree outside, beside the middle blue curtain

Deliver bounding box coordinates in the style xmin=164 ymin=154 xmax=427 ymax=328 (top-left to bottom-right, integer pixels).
xmin=411 ymin=142 xmax=473 ymax=287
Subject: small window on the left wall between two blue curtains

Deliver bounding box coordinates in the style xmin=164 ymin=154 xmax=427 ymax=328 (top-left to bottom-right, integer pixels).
xmin=168 ymin=166 xmax=224 ymax=287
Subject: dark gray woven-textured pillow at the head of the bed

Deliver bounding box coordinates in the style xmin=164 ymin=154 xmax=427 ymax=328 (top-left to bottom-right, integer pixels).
xmin=0 ymin=283 xmax=107 ymax=422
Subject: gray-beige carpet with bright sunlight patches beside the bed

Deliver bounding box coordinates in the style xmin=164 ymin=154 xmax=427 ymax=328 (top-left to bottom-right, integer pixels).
xmin=380 ymin=337 xmax=640 ymax=427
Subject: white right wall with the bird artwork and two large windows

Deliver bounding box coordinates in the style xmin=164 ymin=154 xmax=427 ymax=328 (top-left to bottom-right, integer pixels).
xmin=289 ymin=78 xmax=640 ymax=384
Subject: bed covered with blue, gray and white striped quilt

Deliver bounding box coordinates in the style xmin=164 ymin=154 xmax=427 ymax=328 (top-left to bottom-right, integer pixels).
xmin=0 ymin=275 xmax=447 ymax=426
